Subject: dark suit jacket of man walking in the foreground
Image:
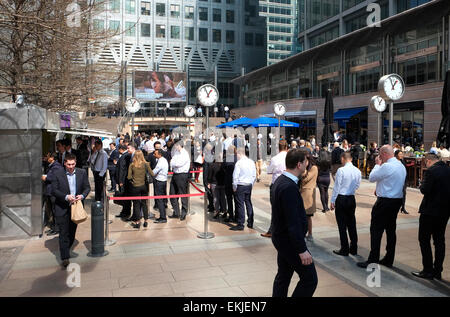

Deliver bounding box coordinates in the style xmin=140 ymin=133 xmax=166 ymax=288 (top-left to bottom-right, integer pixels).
xmin=271 ymin=175 xmax=308 ymax=254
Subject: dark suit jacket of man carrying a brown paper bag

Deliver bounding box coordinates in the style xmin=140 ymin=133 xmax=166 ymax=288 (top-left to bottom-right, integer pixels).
xmin=52 ymin=168 xmax=91 ymax=216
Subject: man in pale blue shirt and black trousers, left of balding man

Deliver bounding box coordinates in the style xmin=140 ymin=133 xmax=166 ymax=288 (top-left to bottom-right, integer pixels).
xmin=331 ymin=152 xmax=361 ymax=256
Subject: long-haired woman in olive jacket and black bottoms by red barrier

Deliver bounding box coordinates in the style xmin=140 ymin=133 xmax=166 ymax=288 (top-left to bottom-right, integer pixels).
xmin=127 ymin=150 xmax=155 ymax=229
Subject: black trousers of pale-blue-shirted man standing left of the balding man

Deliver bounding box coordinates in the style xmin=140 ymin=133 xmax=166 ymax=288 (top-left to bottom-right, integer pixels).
xmin=335 ymin=195 xmax=358 ymax=252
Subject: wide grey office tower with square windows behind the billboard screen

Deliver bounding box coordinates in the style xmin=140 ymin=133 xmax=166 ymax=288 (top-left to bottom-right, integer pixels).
xmin=94 ymin=0 xmax=266 ymax=105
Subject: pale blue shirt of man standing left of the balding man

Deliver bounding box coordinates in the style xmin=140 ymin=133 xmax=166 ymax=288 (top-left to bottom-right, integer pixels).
xmin=331 ymin=162 xmax=361 ymax=204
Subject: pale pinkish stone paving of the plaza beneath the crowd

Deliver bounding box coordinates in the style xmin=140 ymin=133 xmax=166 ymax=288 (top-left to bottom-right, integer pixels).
xmin=0 ymin=170 xmax=450 ymax=297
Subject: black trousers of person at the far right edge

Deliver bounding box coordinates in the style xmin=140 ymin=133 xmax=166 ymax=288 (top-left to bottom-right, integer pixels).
xmin=419 ymin=214 xmax=449 ymax=273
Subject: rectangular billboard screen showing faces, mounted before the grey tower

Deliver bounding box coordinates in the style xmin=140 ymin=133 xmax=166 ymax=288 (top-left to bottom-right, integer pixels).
xmin=134 ymin=71 xmax=187 ymax=102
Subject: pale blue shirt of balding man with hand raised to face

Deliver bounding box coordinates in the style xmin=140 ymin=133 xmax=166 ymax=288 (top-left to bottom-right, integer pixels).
xmin=369 ymin=157 xmax=406 ymax=198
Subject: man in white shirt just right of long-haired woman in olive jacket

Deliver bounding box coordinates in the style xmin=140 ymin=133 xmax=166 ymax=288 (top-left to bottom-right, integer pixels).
xmin=153 ymin=149 xmax=169 ymax=223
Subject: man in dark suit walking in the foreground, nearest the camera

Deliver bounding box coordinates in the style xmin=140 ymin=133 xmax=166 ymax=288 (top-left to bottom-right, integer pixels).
xmin=271 ymin=149 xmax=317 ymax=297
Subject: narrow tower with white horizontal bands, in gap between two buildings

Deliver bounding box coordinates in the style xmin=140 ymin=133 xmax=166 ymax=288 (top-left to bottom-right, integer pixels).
xmin=259 ymin=0 xmax=300 ymax=65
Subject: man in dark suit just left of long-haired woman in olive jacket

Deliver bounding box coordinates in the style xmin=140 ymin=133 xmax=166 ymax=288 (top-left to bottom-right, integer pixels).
xmin=116 ymin=144 xmax=131 ymax=219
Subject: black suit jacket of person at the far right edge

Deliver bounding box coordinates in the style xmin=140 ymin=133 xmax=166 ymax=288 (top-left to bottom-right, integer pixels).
xmin=419 ymin=161 xmax=450 ymax=217
